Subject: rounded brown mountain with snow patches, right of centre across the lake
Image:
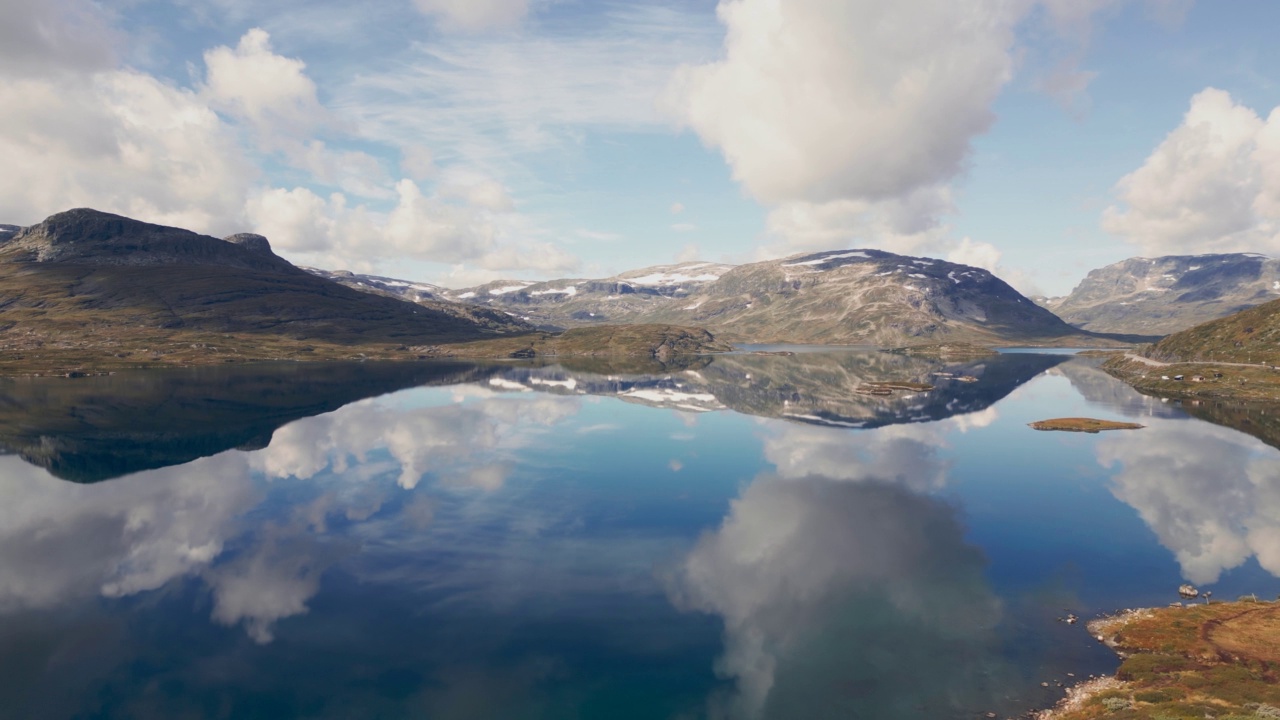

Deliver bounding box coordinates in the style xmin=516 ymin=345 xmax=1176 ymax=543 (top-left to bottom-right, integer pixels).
xmin=640 ymin=250 xmax=1082 ymax=345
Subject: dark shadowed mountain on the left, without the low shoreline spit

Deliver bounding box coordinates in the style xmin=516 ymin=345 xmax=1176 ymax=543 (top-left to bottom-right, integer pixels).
xmin=0 ymin=209 xmax=530 ymax=343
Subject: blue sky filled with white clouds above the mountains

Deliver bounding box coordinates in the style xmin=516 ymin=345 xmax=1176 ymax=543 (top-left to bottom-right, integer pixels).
xmin=0 ymin=0 xmax=1280 ymax=295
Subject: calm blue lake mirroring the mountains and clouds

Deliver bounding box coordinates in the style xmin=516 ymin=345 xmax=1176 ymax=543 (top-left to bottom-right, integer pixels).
xmin=0 ymin=350 xmax=1280 ymax=720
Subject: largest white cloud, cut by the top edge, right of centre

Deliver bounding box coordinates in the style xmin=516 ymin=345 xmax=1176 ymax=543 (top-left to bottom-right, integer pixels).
xmin=666 ymin=0 xmax=1019 ymax=204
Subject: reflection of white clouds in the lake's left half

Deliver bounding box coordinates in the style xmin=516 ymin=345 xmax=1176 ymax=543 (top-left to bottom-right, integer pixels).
xmin=0 ymin=388 xmax=579 ymax=643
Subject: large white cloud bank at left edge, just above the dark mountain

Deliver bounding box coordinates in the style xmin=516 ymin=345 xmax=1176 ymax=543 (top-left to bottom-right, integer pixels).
xmin=0 ymin=70 xmax=257 ymax=234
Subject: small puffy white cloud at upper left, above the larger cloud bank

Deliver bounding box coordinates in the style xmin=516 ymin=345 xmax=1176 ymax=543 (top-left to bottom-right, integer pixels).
xmin=201 ymin=28 xmax=328 ymax=149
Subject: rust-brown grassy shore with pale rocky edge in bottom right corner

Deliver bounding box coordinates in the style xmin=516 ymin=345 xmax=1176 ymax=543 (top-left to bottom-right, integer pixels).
xmin=1038 ymin=596 xmax=1280 ymax=720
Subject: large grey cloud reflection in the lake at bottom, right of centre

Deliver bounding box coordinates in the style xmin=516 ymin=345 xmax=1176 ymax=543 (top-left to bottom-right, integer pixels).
xmin=669 ymin=475 xmax=1002 ymax=717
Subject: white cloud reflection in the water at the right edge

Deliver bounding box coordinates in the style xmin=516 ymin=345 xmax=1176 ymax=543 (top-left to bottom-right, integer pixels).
xmin=1097 ymin=419 xmax=1280 ymax=583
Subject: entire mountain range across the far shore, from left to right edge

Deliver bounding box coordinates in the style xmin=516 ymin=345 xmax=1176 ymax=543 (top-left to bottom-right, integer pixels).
xmin=0 ymin=209 xmax=1280 ymax=364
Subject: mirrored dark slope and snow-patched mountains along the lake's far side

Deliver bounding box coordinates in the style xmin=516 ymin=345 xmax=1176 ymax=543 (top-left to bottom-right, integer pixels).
xmin=0 ymin=352 xmax=1064 ymax=482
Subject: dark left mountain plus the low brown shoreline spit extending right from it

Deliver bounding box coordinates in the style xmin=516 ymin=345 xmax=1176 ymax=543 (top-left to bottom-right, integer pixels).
xmin=0 ymin=209 xmax=727 ymax=372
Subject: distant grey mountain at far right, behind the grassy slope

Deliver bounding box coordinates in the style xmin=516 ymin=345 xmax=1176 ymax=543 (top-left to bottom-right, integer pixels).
xmin=1041 ymin=254 xmax=1280 ymax=336
